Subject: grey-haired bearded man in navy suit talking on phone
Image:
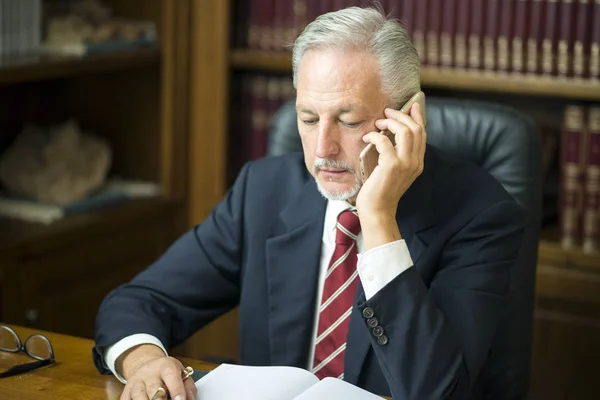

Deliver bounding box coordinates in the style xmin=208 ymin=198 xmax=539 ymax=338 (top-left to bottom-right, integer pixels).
xmin=94 ymin=8 xmax=523 ymax=399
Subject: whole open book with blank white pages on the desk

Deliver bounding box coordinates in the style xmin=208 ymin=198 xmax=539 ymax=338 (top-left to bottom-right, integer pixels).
xmin=196 ymin=364 xmax=381 ymax=400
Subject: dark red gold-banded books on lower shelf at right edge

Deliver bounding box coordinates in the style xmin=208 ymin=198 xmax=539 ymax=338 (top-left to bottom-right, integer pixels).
xmin=559 ymin=104 xmax=600 ymax=253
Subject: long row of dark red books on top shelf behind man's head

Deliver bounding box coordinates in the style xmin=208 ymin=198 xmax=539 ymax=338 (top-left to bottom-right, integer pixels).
xmin=233 ymin=0 xmax=600 ymax=80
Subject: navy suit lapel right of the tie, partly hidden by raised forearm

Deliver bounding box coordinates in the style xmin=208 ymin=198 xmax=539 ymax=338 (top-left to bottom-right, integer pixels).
xmin=344 ymin=148 xmax=435 ymax=385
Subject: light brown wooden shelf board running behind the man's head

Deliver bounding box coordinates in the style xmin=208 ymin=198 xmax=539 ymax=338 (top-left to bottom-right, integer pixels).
xmin=230 ymin=50 xmax=600 ymax=101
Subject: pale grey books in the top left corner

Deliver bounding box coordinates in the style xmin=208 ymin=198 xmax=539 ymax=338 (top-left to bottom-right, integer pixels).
xmin=0 ymin=0 xmax=42 ymax=57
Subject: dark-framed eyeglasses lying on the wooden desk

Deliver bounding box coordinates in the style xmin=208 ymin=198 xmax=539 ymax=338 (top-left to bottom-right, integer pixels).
xmin=0 ymin=325 xmax=56 ymax=378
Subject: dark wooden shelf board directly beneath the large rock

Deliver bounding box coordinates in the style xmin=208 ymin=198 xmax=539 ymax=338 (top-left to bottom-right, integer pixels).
xmin=0 ymin=197 xmax=176 ymax=255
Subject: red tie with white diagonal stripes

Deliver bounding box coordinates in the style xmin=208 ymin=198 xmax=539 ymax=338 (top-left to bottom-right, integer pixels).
xmin=312 ymin=211 xmax=360 ymax=379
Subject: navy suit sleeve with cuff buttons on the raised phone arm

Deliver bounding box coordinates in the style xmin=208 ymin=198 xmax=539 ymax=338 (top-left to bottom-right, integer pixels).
xmin=357 ymin=202 xmax=524 ymax=399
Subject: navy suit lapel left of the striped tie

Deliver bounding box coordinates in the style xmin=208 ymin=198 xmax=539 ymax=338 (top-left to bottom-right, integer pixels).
xmin=266 ymin=178 xmax=326 ymax=368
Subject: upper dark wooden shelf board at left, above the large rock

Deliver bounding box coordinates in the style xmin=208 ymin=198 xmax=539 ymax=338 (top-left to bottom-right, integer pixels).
xmin=0 ymin=47 xmax=160 ymax=85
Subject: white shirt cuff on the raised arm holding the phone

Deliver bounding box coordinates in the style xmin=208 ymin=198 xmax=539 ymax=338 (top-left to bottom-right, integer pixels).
xmin=356 ymin=240 xmax=413 ymax=300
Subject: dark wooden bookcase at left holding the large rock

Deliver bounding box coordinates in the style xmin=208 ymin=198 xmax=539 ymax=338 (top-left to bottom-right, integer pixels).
xmin=0 ymin=0 xmax=197 ymax=337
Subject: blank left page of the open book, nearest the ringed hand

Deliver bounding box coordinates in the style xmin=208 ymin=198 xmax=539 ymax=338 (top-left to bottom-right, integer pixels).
xmin=196 ymin=364 xmax=319 ymax=400
